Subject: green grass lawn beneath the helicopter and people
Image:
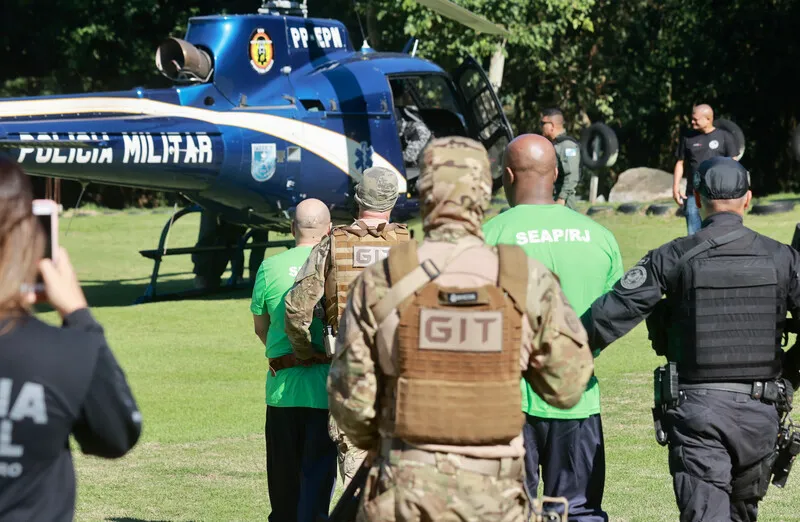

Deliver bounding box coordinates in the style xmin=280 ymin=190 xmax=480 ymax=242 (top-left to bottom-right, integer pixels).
xmin=43 ymin=203 xmax=800 ymax=522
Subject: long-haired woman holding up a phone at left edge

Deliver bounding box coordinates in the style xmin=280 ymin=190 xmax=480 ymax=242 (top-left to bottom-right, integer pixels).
xmin=0 ymin=156 xmax=142 ymax=521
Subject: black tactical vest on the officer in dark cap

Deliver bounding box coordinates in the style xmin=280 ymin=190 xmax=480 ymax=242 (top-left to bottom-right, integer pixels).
xmin=668 ymin=229 xmax=786 ymax=382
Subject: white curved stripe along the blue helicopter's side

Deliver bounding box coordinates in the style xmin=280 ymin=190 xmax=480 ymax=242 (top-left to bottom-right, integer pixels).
xmin=0 ymin=97 xmax=407 ymax=192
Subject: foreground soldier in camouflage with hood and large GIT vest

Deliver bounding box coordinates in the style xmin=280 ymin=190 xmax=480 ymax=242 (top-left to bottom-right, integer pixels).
xmin=328 ymin=137 xmax=593 ymax=521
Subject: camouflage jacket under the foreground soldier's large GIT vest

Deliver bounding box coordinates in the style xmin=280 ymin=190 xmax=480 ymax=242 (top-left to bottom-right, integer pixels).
xmin=328 ymin=236 xmax=594 ymax=458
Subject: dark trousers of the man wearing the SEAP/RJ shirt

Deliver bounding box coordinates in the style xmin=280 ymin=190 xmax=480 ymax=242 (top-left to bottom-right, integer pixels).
xmin=522 ymin=414 xmax=608 ymax=522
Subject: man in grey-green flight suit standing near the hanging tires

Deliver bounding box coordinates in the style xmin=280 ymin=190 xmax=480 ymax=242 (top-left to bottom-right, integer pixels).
xmin=541 ymin=109 xmax=581 ymax=210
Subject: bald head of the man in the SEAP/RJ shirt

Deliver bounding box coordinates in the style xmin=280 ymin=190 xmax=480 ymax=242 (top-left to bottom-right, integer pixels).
xmin=503 ymin=134 xmax=558 ymax=206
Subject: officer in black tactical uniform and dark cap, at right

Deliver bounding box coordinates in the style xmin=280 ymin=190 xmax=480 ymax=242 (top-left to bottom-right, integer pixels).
xmin=582 ymin=157 xmax=800 ymax=522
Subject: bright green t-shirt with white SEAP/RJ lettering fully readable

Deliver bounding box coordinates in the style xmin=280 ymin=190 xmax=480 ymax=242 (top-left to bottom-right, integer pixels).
xmin=483 ymin=204 xmax=623 ymax=419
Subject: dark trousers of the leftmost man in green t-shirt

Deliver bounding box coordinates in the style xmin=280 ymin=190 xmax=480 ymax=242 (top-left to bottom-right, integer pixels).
xmin=264 ymin=406 xmax=336 ymax=522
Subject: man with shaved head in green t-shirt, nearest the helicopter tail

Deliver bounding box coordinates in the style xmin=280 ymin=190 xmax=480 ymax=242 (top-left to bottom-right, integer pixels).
xmin=250 ymin=199 xmax=336 ymax=522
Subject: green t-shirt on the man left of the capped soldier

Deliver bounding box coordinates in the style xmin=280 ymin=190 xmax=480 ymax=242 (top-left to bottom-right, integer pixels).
xmin=250 ymin=246 xmax=330 ymax=410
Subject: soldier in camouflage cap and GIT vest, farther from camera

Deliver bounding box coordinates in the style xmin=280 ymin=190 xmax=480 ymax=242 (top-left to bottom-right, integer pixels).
xmin=285 ymin=167 xmax=409 ymax=487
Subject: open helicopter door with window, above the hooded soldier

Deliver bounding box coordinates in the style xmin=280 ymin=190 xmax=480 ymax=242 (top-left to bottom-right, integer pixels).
xmin=453 ymin=56 xmax=514 ymax=190
